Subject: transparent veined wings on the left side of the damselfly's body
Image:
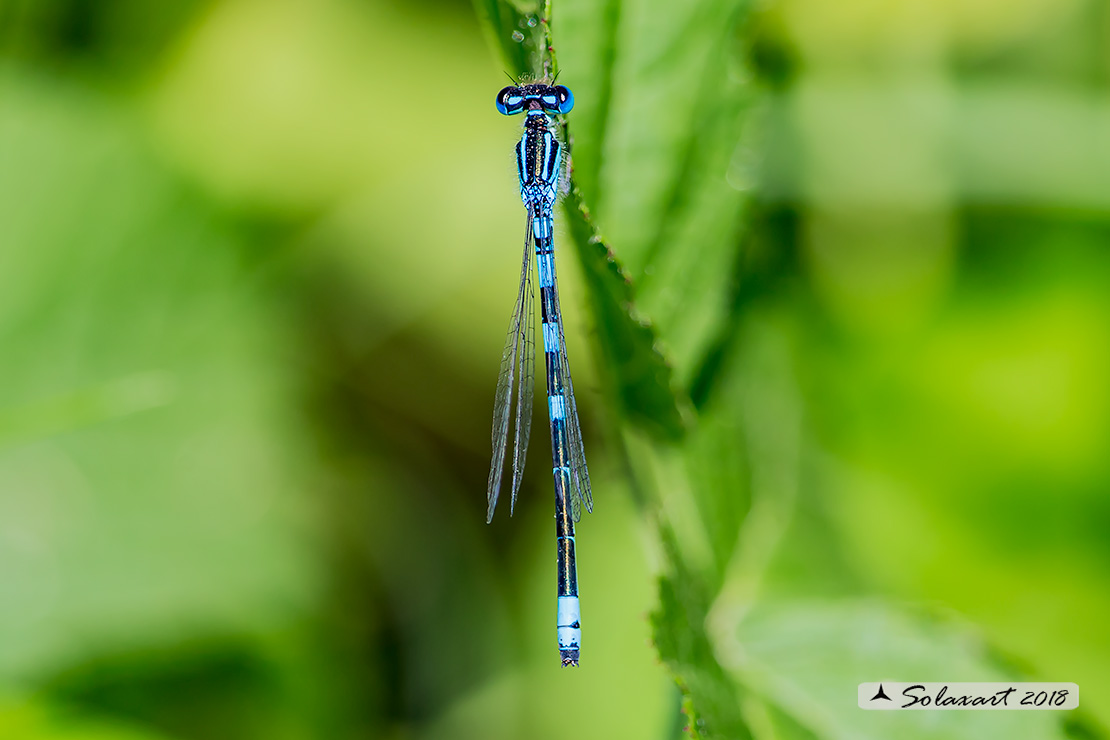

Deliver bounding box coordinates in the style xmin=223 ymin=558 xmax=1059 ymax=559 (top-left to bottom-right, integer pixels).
xmin=486 ymin=219 xmax=536 ymax=524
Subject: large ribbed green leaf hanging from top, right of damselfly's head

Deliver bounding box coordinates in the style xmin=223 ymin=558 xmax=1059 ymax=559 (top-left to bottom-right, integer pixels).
xmin=552 ymin=0 xmax=758 ymax=388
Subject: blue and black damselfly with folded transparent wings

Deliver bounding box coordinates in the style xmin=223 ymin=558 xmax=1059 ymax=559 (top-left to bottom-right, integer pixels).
xmin=486 ymin=84 xmax=593 ymax=666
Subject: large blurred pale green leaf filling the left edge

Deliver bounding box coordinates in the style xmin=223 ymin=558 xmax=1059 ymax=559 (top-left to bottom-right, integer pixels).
xmin=0 ymin=69 xmax=315 ymax=681
